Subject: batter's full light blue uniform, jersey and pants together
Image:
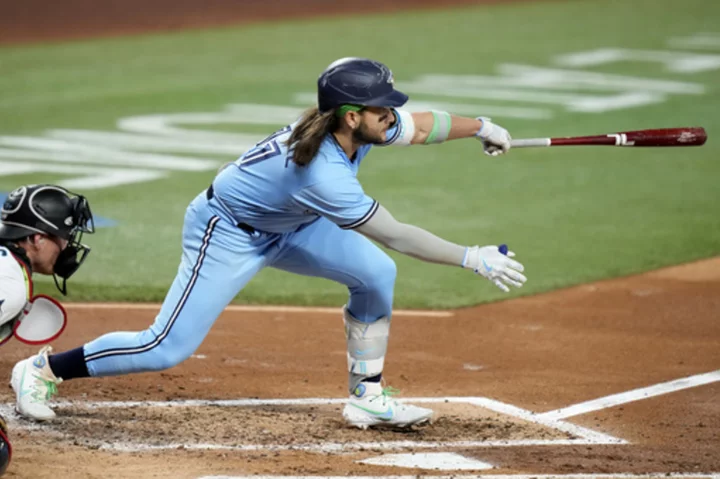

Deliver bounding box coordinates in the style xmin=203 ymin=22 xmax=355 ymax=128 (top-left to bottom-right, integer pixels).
xmin=83 ymin=113 xmax=411 ymax=376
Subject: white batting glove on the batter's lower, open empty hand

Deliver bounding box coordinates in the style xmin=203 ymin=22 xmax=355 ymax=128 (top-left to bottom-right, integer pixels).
xmin=462 ymin=245 xmax=527 ymax=293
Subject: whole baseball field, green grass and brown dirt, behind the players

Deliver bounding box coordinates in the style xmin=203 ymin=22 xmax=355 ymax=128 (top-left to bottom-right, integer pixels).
xmin=0 ymin=0 xmax=720 ymax=479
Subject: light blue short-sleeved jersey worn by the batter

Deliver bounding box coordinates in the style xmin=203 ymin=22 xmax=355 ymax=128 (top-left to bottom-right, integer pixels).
xmin=213 ymin=113 xmax=402 ymax=233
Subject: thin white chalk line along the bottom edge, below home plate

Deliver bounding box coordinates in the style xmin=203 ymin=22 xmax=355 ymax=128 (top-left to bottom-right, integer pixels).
xmin=198 ymin=472 xmax=720 ymax=479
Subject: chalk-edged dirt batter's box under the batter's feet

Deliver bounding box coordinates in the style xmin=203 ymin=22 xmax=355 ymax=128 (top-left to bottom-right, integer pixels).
xmin=2 ymin=397 xmax=625 ymax=455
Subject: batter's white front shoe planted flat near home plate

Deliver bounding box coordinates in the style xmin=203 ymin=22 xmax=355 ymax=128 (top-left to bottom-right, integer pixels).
xmin=343 ymin=383 xmax=433 ymax=429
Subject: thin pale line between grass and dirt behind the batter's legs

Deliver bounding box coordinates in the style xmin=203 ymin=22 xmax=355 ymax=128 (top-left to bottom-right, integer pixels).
xmin=63 ymin=303 xmax=455 ymax=318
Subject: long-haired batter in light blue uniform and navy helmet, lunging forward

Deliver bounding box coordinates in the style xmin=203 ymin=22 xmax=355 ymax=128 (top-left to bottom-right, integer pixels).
xmin=12 ymin=58 xmax=526 ymax=428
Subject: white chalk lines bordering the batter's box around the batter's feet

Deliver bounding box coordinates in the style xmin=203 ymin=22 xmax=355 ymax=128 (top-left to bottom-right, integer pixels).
xmin=0 ymin=397 xmax=626 ymax=452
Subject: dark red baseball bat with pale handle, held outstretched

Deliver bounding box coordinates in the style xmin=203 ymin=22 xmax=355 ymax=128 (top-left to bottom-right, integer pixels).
xmin=511 ymin=127 xmax=707 ymax=148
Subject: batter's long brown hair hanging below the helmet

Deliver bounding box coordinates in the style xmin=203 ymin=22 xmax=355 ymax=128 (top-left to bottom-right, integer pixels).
xmin=287 ymin=107 xmax=339 ymax=166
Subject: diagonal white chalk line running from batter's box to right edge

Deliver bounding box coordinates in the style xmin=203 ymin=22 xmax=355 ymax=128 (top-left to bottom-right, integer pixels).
xmin=537 ymin=369 xmax=720 ymax=420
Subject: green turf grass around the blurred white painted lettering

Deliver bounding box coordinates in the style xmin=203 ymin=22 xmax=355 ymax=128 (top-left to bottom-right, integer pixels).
xmin=0 ymin=0 xmax=720 ymax=308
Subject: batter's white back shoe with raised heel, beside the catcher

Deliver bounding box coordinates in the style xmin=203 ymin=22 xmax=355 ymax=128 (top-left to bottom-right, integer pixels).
xmin=10 ymin=346 xmax=62 ymax=421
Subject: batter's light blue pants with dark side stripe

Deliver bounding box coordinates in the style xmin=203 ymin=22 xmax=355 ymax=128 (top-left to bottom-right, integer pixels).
xmin=84 ymin=193 xmax=397 ymax=376
